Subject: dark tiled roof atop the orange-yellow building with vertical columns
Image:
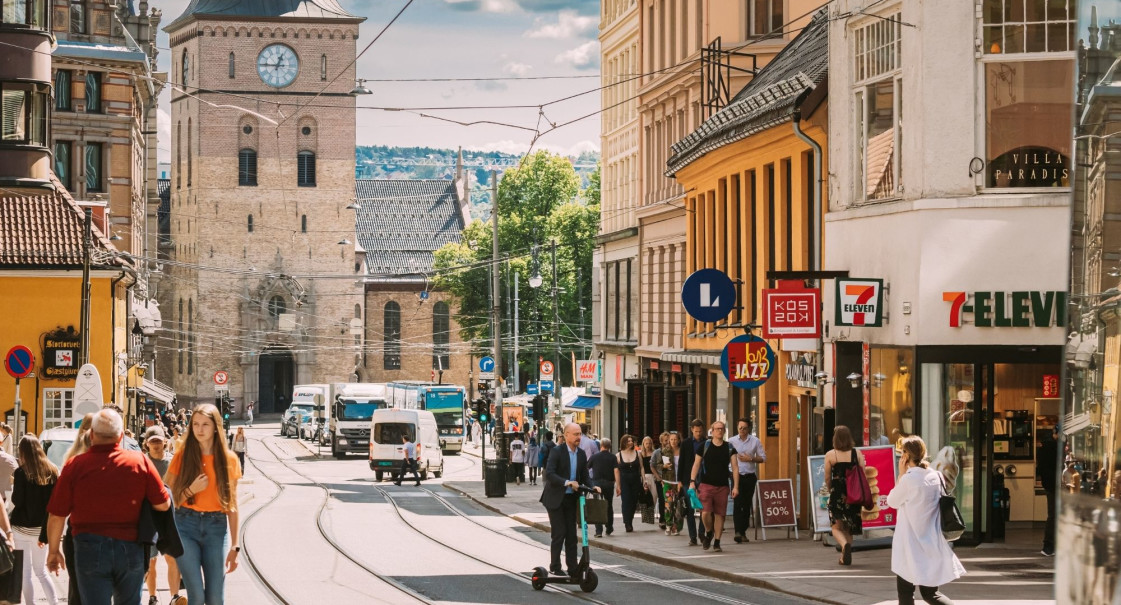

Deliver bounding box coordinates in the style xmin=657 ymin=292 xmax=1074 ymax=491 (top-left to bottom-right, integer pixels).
xmin=666 ymin=9 xmax=828 ymax=176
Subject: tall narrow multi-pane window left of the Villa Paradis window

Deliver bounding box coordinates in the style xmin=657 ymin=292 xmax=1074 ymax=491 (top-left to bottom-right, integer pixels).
xmin=853 ymin=13 xmax=902 ymax=202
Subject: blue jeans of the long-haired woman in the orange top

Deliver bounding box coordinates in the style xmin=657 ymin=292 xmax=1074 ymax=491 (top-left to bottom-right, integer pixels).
xmin=175 ymin=509 xmax=230 ymax=605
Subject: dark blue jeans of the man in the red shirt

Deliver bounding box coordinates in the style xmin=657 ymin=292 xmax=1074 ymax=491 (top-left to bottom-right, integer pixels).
xmin=71 ymin=533 xmax=148 ymax=605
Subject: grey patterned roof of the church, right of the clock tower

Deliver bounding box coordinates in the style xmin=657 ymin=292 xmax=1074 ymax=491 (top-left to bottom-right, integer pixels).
xmin=354 ymin=179 xmax=465 ymax=278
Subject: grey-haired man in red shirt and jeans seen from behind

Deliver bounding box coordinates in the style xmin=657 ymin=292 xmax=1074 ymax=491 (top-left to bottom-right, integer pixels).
xmin=47 ymin=409 xmax=172 ymax=605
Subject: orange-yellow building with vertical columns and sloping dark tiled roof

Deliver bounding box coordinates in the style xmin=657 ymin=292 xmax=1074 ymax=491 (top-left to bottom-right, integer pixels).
xmin=663 ymin=11 xmax=827 ymax=524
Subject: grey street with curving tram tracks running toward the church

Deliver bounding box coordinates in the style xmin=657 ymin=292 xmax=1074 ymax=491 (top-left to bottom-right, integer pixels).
xmin=242 ymin=425 xmax=810 ymax=605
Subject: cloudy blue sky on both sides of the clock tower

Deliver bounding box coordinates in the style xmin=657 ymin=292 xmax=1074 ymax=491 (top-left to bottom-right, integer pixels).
xmin=150 ymin=0 xmax=600 ymax=161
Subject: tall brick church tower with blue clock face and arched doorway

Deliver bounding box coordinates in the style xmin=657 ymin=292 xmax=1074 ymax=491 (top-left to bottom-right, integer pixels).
xmin=157 ymin=0 xmax=364 ymax=413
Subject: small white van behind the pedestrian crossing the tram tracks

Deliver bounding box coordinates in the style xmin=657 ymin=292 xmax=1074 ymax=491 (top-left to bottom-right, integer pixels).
xmin=370 ymin=408 xmax=444 ymax=481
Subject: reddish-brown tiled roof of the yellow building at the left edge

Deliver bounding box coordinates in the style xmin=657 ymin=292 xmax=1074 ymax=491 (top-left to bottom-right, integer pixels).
xmin=0 ymin=180 xmax=120 ymax=269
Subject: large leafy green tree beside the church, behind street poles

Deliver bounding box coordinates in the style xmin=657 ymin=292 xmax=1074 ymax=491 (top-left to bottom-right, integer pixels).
xmin=435 ymin=151 xmax=600 ymax=384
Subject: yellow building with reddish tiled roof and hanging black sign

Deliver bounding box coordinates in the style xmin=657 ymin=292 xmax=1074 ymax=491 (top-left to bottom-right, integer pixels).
xmin=0 ymin=193 xmax=135 ymax=434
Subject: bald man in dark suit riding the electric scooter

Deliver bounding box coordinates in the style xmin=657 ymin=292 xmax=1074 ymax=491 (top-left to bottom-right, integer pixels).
xmin=541 ymin=422 xmax=589 ymax=576
